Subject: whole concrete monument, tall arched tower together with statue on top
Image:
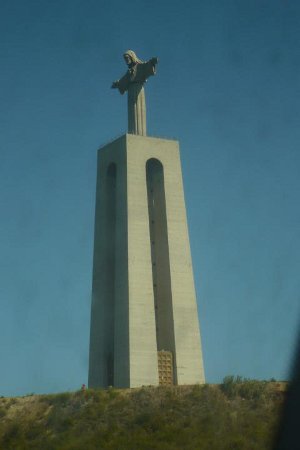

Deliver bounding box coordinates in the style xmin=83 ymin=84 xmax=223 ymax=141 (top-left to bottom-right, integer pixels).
xmin=89 ymin=51 xmax=204 ymax=387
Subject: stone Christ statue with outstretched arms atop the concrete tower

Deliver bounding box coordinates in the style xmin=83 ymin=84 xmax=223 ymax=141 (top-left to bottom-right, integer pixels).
xmin=111 ymin=50 xmax=158 ymax=136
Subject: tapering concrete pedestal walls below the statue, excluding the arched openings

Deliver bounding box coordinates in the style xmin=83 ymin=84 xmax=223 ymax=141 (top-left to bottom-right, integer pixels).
xmin=89 ymin=134 xmax=204 ymax=387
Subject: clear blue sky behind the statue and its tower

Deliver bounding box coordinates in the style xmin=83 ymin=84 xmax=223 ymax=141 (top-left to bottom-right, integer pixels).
xmin=0 ymin=0 xmax=300 ymax=395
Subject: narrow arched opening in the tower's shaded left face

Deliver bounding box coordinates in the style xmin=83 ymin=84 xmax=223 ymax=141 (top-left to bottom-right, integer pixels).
xmin=103 ymin=163 xmax=117 ymax=386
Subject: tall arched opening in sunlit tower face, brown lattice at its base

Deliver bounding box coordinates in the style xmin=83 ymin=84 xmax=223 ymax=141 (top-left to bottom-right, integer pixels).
xmin=146 ymin=158 xmax=177 ymax=384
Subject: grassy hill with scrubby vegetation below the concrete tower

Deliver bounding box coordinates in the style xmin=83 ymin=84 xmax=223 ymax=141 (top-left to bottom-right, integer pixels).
xmin=0 ymin=377 xmax=285 ymax=450
